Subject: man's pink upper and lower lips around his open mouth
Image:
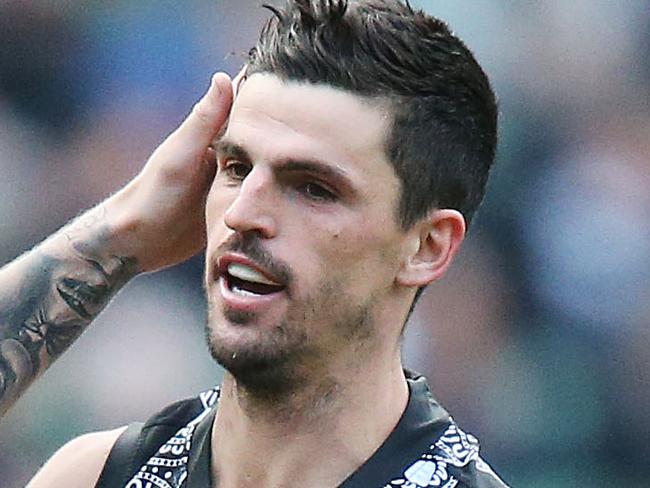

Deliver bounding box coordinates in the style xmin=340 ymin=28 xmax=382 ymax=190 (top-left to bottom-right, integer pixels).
xmin=215 ymin=253 xmax=285 ymax=312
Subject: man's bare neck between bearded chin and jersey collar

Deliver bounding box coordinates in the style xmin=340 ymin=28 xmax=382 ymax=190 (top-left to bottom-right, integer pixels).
xmin=212 ymin=351 xmax=408 ymax=488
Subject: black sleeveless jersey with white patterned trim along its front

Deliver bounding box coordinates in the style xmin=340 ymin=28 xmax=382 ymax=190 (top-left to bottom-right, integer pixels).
xmin=96 ymin=372 xmax=507 ymax=488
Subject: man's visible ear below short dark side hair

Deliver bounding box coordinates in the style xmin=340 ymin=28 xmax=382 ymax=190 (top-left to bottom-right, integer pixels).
xmin=396 ymin=209 xmax=466 ymax=287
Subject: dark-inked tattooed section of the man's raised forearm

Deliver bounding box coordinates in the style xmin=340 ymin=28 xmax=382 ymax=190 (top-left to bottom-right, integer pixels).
xmin=0 ymin=211 xmax=136 ymax=415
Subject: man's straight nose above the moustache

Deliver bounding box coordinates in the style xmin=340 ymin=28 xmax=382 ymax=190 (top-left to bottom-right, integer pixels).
xmin=224 ymin=166 xmax=277 ymax=239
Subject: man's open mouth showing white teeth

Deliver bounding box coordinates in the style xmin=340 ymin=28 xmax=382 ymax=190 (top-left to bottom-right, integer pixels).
xmin=217 ymin=255 xmax=286 ymax=298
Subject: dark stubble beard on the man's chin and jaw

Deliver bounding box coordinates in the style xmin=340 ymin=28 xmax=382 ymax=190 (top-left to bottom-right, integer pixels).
xmin=206 ymin=283 xmax=374 ymax=403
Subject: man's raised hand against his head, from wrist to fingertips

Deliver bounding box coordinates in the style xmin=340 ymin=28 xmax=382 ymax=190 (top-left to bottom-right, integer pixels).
xmin=106 ymin=73 xmax=233 ymax=272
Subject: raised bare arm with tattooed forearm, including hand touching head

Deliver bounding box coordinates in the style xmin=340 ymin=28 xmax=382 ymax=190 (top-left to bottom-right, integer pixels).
xmin=0 ymin=70 xmax=232 ymax=416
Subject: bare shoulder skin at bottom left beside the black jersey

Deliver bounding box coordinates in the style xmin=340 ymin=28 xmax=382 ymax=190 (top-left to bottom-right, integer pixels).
xmin=27 ymin=427 xmax=126 ymax=488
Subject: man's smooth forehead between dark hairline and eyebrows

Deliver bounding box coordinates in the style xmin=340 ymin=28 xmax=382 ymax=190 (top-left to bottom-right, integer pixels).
xmin=226 ymin=74 xmax=395 ymax=183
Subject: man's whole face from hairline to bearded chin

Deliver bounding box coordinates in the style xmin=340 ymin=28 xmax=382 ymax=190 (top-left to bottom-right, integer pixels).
xmin=205 ymin=74 xmax=404 ymax=387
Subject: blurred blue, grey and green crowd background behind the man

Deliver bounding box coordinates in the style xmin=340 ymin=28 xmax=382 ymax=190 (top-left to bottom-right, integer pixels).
xmin=0 ymin=0 xmax=650 ymax=488
